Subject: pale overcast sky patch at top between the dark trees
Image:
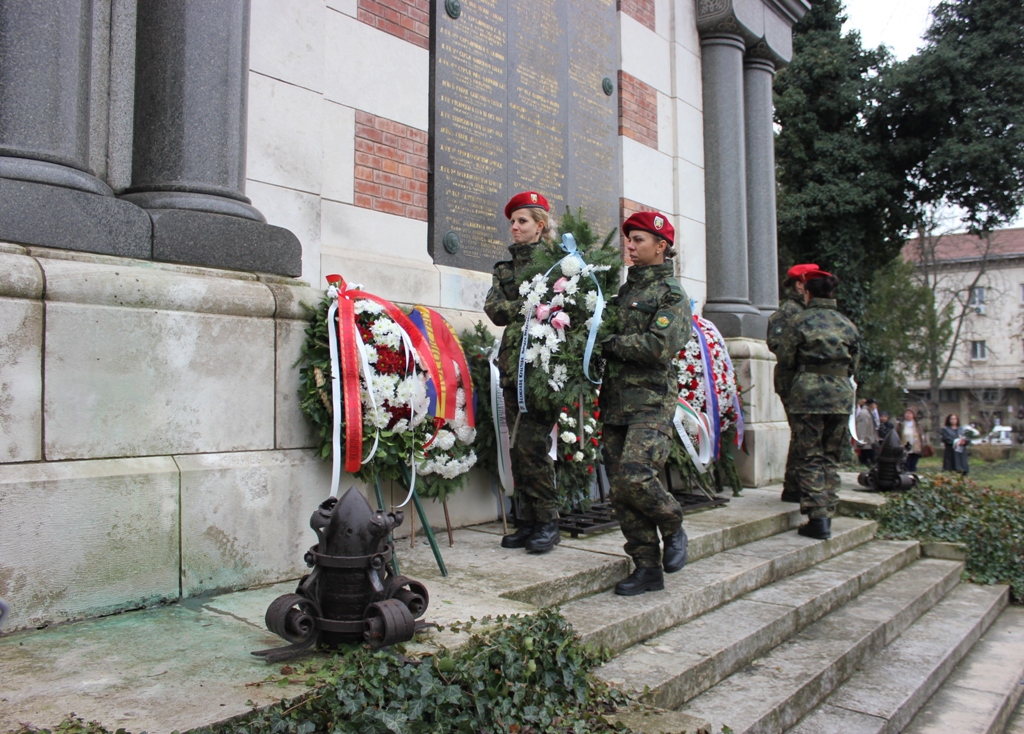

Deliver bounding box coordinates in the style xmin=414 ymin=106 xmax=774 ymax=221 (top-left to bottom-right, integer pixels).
xmin=844 ymin=0 xmax=936 ymax=60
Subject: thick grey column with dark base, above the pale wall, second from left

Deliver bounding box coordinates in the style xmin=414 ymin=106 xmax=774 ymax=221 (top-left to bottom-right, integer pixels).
xmin=122 ymin=0 xmax=301 ymax=275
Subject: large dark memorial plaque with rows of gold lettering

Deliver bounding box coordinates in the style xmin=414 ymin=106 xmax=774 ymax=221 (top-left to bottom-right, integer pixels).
xmin=430 ymin=0 xmax=621 ymax=271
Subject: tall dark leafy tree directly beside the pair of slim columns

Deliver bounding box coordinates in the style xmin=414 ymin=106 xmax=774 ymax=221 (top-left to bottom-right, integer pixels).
xmin=775 ymin=0 xmax=905 ymax=389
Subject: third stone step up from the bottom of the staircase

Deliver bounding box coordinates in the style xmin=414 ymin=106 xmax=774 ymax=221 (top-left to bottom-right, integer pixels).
xmin=680 ymin=559 xmax=964 ymax=734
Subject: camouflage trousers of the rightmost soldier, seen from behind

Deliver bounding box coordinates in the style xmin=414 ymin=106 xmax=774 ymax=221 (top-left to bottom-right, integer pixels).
xmin=790 ymin=413 xmax=850 ymax=519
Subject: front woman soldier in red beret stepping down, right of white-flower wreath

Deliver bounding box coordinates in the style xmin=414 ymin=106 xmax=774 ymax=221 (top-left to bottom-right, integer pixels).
xmin=600 ymin=212 xmax=691 ymax=596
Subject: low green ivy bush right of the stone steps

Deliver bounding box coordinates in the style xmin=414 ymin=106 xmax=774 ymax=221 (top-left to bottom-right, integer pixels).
xmin=879 ymin=474 xmax=1024 ymax=603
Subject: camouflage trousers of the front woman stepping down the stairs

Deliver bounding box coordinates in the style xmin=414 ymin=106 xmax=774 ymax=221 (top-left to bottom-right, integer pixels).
xmin=602 ymin=424 xmax=683 ymax=567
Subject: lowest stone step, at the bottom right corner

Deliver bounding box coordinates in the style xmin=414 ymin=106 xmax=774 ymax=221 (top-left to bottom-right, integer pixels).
xmin=904 ymin=607 xmax=1024 ymax=734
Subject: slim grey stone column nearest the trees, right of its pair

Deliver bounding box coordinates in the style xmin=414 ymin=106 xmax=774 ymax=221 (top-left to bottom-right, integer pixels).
xmin=743 ymin=55 xmax=778 ymax=339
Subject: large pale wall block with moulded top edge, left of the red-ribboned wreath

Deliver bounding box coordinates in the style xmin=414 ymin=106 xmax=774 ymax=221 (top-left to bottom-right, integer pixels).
xmin=41 ymin=260 xmax=274 ymax=461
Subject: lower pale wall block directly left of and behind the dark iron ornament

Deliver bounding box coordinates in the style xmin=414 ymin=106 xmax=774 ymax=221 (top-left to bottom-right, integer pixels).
xmin=175 ymin=449 xmax=331 ymax=596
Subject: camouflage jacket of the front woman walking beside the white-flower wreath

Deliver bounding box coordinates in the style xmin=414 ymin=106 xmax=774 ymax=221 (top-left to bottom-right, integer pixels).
xmin=600 ymin=262 xmax=692 ymax=423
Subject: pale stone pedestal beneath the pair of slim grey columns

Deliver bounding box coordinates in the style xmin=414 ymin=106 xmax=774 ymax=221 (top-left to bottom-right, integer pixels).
xmin=725 ymin=339 xmax=790 ymax=487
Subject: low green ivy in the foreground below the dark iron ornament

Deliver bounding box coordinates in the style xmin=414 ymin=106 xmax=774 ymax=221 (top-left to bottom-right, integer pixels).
xmin=19 ymin=609 xmax=629 ymax=734
